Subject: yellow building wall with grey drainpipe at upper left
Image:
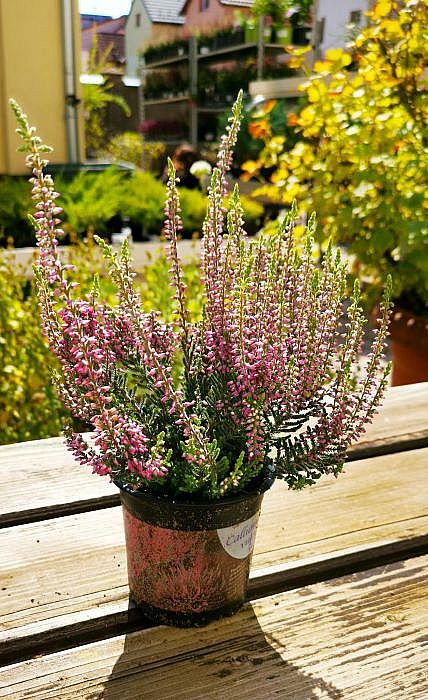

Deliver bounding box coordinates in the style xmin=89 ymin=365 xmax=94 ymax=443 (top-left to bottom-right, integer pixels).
xmin=0 ymin=0 xmax=84 ymax=175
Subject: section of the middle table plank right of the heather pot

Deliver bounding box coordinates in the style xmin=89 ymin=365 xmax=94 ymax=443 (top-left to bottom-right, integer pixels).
xmin=254 ymin=448 xmax=428 ymax=566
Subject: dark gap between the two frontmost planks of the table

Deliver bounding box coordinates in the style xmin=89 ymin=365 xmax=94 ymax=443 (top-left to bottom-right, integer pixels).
xmin=0 ymin=534 xmax=428 ymax=666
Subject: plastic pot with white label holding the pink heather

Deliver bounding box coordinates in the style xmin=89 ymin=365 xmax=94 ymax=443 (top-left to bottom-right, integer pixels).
xmin=116 ymin=476 xmax=273 ymax=627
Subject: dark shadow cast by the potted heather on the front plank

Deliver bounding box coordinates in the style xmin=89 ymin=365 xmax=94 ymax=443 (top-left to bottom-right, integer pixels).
xmin=100 ymin=605 xmax=343 ymax=700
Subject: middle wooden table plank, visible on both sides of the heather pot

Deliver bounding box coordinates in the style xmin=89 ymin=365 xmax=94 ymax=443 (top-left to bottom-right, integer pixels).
xmin=0 ymin=448 xmax=428 ymax=658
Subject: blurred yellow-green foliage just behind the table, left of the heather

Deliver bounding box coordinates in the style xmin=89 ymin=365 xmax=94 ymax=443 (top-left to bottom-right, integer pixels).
xmin=0 ymin=240 xmax=201 ymax=445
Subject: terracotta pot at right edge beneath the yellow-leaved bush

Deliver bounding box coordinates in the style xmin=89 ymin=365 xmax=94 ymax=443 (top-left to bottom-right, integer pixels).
xmin=390 ymin=309 xmax=428 ymax=386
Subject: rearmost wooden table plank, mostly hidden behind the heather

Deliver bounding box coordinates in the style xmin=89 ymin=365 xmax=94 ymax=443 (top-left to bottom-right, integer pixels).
xmin=0 ymin=382 xmax=428 ymax=527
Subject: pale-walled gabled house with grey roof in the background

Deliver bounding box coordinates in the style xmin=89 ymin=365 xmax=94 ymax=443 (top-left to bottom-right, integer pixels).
xmin=125 ymin=0 xmax=184 ymax=78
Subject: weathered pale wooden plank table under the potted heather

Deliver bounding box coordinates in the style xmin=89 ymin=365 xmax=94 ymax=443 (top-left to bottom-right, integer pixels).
xmin=0 ymin=383 xmax=428 ymax=700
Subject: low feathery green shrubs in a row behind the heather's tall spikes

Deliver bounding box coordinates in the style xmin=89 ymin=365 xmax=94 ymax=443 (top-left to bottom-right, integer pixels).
xmin=0 ymin=166 xmax=263 ymax=247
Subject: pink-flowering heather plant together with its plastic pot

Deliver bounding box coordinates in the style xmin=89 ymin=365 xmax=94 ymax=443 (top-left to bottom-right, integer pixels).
xmin=13 ymin=94 xmax=390 ymax=626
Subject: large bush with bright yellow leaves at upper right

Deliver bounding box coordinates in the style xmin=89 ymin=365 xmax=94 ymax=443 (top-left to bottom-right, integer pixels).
xmin=246 ymin=0 xmax=428 ymax=312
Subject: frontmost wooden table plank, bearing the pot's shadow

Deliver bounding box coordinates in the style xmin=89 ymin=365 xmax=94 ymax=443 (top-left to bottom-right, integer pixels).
xmin=0 ymin=556 xmax=428 ymax=700
